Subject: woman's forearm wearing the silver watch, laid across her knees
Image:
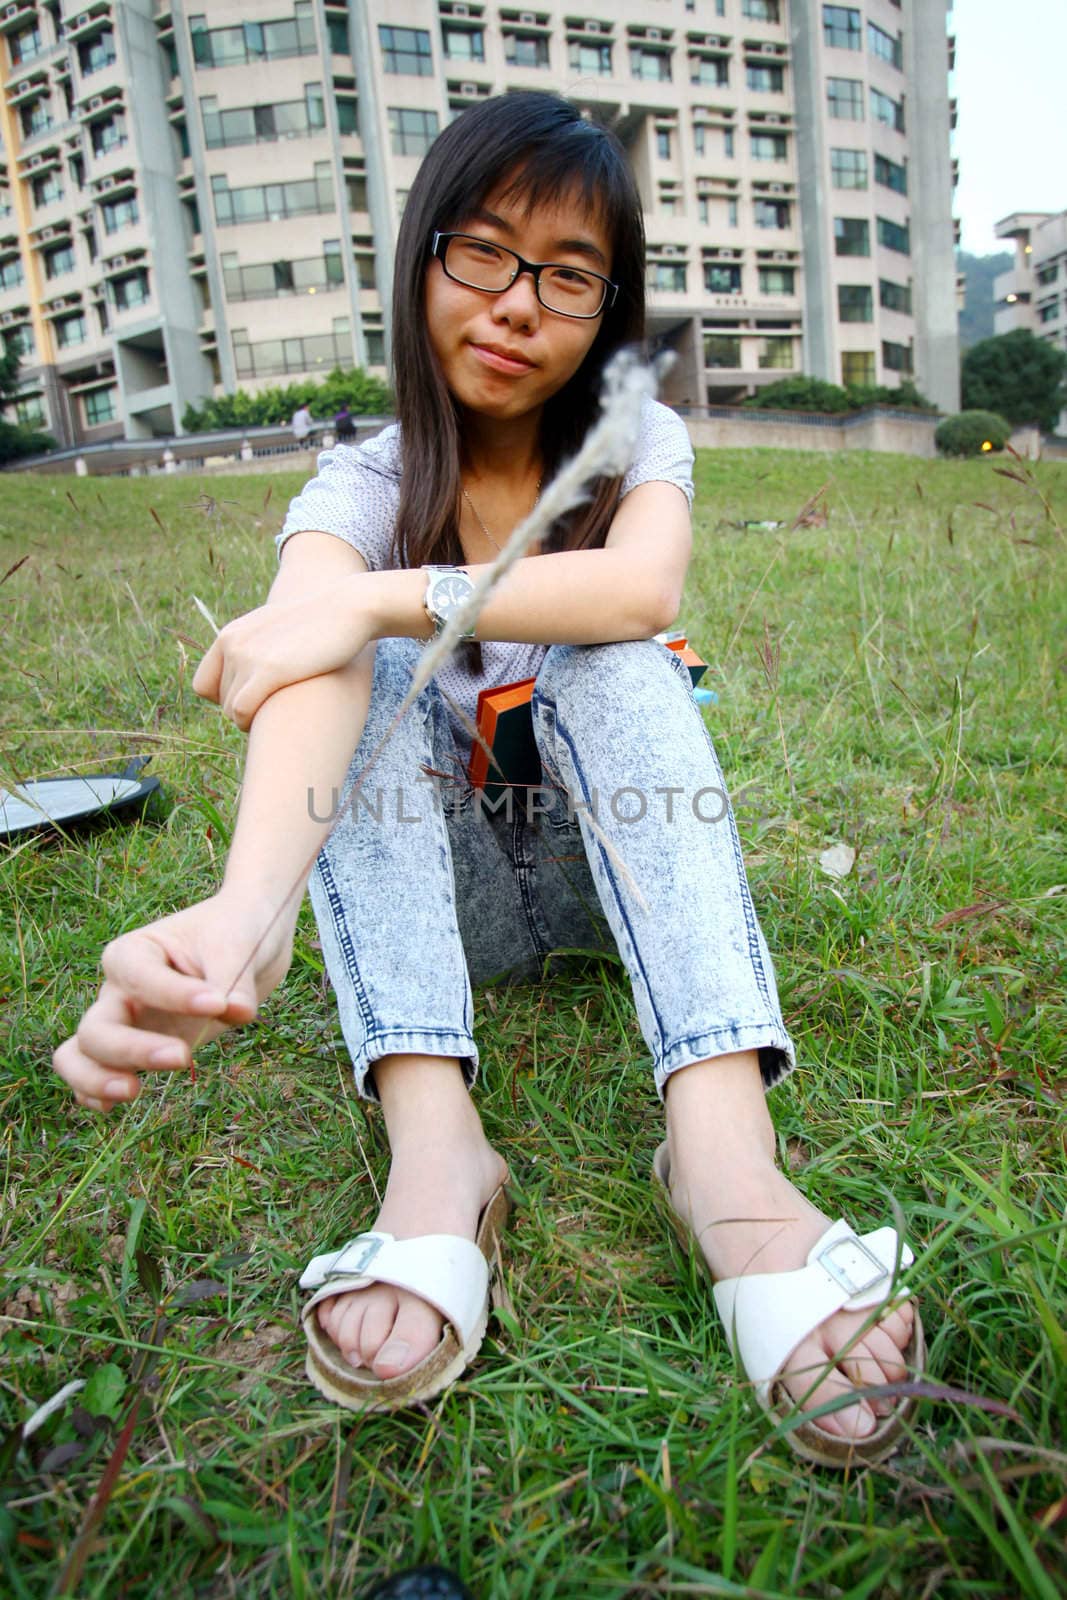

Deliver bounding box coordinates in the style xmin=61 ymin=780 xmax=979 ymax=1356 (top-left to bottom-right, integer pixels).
xmin=363 ymin=549 xmax=677 ymax=645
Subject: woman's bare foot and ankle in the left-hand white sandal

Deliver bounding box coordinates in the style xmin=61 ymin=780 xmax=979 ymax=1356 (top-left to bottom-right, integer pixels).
xmin=315 ymin=1058 xmax=507 ymax=1378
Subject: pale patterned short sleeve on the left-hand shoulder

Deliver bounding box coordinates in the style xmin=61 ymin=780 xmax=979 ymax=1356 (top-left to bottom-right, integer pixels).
xmin=274 ymin=445 xmax=400 ymax=571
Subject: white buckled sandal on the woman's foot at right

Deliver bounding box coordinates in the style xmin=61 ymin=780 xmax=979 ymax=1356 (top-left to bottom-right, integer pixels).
xmin=653 ymin=1144 xmax=926 ymax=1467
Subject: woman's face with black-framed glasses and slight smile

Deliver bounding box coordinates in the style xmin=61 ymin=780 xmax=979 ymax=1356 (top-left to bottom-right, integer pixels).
xmin=424 ymin=181 xmax=613 ymax=419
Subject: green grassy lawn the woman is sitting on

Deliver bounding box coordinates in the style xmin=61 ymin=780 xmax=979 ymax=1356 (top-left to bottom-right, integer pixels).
xmin=0 ymin=450 xmax=1067 ymax=1600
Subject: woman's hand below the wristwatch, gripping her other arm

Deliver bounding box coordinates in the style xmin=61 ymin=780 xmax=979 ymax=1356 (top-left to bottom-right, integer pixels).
xmin=192 ymin=579 xmax=376 ymax=733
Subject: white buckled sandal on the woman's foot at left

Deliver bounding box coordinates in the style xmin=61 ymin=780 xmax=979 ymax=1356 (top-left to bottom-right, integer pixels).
xmin=301 ymin=1184 xmax=507 ymax=1411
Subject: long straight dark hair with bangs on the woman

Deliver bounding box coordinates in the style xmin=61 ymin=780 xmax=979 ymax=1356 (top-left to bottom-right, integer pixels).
xmin=392 ymin=90 xmax=645 ymax=670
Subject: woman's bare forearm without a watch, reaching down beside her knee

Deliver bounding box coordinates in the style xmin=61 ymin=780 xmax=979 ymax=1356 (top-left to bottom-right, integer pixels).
xmin=224 ymin=648 xmax=374 ymax=922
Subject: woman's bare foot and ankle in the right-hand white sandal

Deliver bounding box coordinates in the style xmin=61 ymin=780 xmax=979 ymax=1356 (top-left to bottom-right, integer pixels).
xmin=667 ymin=1053 xmax=915 ymax=1440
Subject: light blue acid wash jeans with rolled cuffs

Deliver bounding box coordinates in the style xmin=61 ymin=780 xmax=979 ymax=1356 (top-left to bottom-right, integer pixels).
xmin=307 ymin=638 xmax=795 ymax=1099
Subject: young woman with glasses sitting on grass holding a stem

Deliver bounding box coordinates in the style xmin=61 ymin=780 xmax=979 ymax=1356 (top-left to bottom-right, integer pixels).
xmin=54 ymin=93 xmax=921 ymax=1462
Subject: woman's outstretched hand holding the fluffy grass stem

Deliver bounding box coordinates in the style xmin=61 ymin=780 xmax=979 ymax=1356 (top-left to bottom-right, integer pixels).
xmin=53 ymin=890 xmax=294 ymax=1110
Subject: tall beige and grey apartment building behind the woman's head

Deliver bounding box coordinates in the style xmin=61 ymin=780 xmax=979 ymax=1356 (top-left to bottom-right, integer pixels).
xmin=0 ymin=0 xmax=958 ymax=442
